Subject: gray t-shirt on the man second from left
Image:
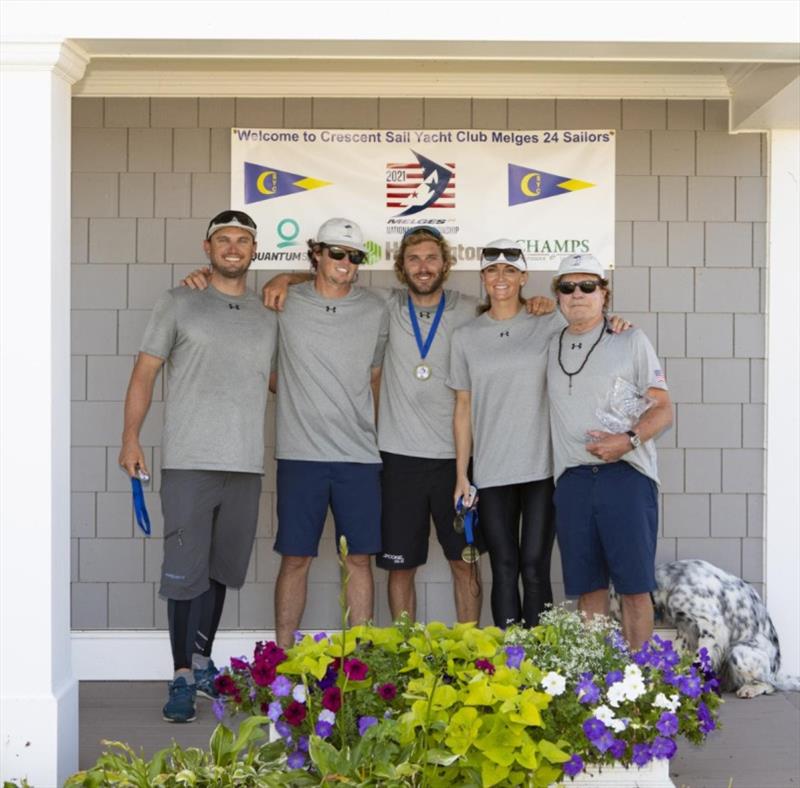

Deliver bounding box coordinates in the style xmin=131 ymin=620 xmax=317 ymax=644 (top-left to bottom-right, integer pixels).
xmin=275 ymin=282 xmax=389 ymax=463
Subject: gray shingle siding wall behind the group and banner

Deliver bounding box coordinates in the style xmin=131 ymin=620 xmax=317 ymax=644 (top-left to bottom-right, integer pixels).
xmin=72 ymin=98 xmax=766 ymax=629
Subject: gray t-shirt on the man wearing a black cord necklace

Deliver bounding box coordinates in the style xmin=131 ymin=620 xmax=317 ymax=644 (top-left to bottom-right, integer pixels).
xmin=547 ymin=325 xmax=667 ymax=484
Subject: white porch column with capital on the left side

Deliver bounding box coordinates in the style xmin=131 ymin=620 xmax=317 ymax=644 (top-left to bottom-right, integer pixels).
xmin=0 ymin=42 xmax=87 ymax=786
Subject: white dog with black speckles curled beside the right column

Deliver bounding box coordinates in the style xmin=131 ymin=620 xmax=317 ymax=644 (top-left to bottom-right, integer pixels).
xmin=610 ymin=559 xmax=800 ymax=698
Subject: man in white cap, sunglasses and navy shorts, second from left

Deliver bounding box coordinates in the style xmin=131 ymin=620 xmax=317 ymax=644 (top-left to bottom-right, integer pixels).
xmin=272 ymin=218 xmax=389 ymax=648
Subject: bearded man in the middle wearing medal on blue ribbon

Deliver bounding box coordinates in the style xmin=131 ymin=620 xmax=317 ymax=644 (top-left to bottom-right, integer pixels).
xmin=264 ymin=225 xmax=552 ymax=622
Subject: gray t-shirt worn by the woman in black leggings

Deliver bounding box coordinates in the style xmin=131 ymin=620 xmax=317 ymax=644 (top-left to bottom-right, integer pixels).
xmin=447 ymin=307 xmax=564 ymax=489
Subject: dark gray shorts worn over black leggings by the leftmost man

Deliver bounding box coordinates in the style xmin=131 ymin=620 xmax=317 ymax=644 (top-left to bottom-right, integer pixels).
xmin=159 ymin=470 xmax=261 ymax=599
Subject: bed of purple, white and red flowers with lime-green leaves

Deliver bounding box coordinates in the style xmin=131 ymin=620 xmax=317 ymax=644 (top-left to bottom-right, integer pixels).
xmin=211 ymin=608 xmax=720 ymax=786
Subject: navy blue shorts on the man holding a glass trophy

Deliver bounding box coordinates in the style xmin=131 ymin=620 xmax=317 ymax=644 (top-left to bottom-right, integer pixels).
xmin=553 ymin=461 xmax=658 ymax=596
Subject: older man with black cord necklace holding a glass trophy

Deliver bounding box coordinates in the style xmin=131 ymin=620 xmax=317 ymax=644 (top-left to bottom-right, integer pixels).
xmin=547 ymin=254 xmax=672 ymax=649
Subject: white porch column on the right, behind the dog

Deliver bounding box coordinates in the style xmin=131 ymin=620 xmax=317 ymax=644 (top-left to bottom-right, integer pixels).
xmin=765 ymin=129 xmax=800 ymax=674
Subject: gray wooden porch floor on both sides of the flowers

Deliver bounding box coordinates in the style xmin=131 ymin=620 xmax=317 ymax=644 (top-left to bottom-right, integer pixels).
xmin=80 ymin=681 xmax=800 ymax=788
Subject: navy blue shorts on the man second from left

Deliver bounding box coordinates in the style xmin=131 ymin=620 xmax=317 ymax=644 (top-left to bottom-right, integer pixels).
xmin=275 ymin=460 xmax=381 ymax=556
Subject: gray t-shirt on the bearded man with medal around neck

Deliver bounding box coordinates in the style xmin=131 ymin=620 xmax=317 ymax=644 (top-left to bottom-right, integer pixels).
xmin=376 ymin=288 xmax=478 ymax=459
